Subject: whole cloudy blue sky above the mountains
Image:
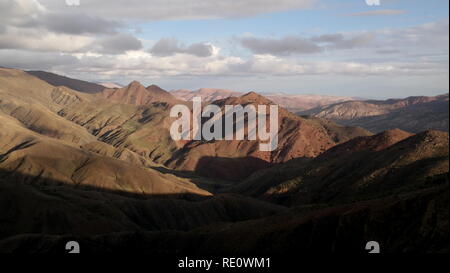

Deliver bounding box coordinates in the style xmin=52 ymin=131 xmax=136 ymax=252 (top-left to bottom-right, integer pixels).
xmin=0 ymin=0 xmax=449 ymax=98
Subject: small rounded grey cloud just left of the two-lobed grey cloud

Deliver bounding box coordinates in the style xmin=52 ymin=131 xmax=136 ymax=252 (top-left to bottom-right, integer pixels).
xmin=95 ymin=33 xmax=142 ymax=54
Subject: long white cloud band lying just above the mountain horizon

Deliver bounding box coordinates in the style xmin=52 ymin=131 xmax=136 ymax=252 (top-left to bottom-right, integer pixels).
xmin=4 ymin=46 xmax=442 ymax=81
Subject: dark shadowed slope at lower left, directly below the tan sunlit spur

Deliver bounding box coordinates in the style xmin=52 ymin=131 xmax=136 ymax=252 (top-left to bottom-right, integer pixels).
xmin=0 ymin=172 xmax=285 ymax=238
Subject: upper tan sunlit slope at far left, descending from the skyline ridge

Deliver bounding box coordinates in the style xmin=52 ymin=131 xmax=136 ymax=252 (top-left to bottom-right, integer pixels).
xmin=0 ymin=69 xmax=172 ymax=166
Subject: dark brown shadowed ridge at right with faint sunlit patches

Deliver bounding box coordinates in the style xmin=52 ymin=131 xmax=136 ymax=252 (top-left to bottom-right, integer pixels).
xmin=235 ymin=130 xmax=449 ymax=204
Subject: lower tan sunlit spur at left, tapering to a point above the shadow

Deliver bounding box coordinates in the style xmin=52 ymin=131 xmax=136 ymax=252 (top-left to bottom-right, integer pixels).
xmin=0 ymin=115 xmax=209 ymax=195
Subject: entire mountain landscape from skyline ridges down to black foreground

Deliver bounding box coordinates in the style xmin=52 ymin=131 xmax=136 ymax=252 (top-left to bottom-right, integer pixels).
xmin=0 ymin=68 xmax=450 ymax=255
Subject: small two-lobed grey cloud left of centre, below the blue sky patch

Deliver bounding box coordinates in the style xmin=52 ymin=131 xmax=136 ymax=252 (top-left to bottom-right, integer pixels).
xmin=149 ymin=38 xmax=213 ymax=57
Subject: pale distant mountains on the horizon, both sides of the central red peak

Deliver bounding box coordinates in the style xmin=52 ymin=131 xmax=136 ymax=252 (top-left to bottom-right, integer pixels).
xmin=171 ymin=88 xmax=449 ymax=133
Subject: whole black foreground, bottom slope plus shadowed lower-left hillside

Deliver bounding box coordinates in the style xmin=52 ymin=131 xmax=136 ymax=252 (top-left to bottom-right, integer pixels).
xmin=0 ymin=168 xmax=449 ymax=253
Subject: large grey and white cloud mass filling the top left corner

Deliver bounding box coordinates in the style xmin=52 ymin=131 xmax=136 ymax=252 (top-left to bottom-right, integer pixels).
xmin=0 ymin=0 xmax=125 ymax=53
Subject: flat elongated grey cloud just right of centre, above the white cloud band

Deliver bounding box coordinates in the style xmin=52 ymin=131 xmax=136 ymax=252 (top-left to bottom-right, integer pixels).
xmin=240 ymin=36 xmax=322 ymax=56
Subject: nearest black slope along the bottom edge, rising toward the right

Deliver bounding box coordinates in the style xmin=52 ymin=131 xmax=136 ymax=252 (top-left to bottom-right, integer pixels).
xmin=0 ymin=181 xmax=449 ymax=254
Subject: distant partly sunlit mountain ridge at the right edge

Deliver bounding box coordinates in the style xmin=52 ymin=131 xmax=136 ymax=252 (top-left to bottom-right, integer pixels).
xmin=298 ymin=94 xmax=449 ymax=133
